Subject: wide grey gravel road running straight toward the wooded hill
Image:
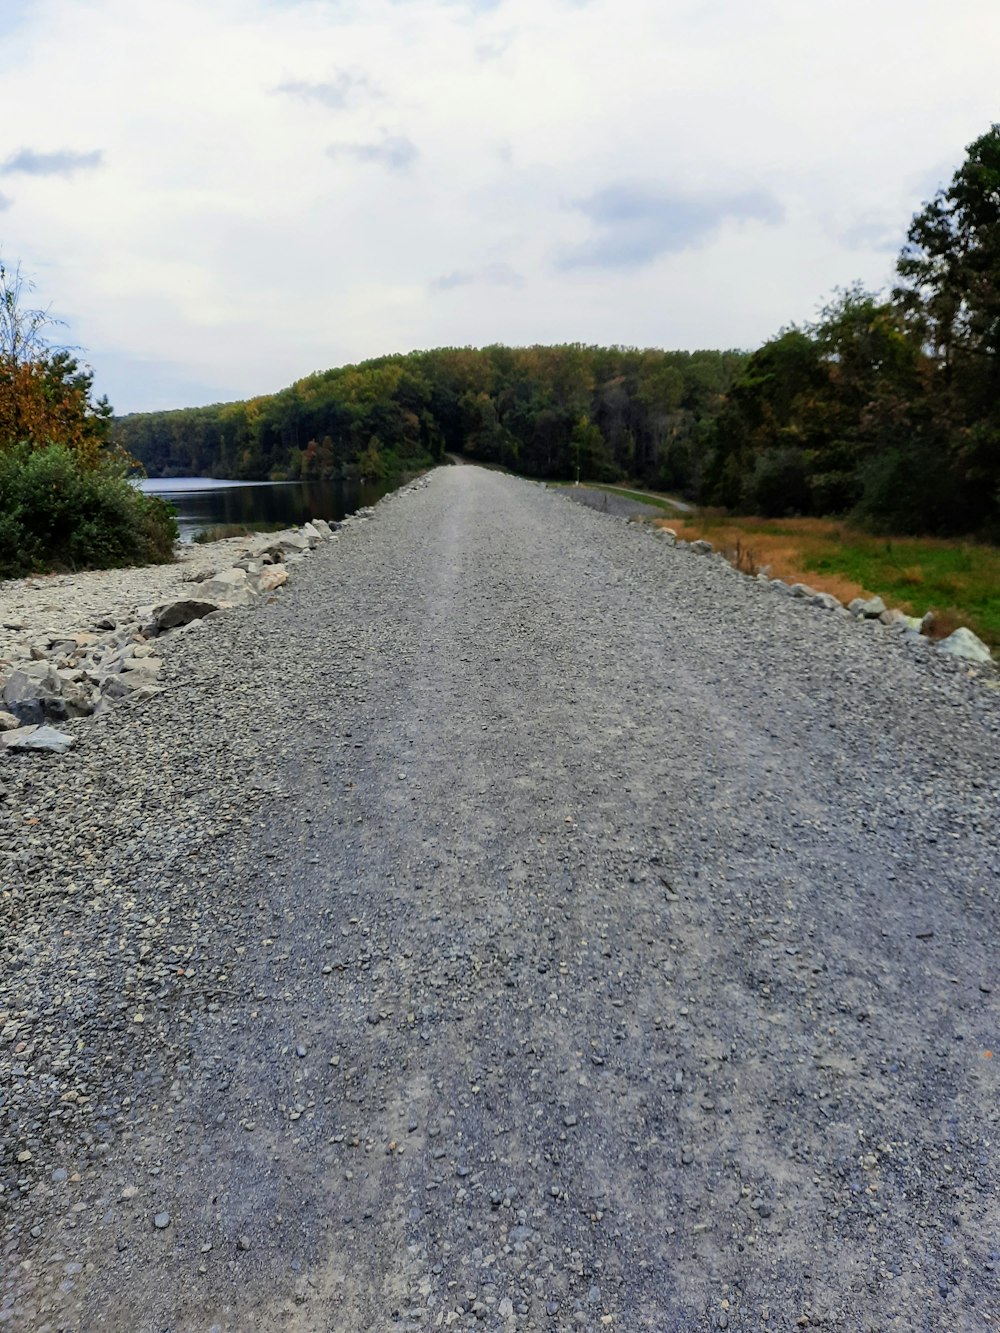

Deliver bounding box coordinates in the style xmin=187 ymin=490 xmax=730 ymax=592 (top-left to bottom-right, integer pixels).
xmin=0 ymin=467 xmax=1000 ymax=1333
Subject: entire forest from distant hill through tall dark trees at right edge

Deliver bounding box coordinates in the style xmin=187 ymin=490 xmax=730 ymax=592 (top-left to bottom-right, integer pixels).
xmin=115 ymin=124 xmax=1000 ymax=540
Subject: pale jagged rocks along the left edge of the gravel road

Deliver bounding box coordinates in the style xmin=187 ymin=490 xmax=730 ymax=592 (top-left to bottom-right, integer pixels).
xmin=0 ymin=519 xmax=340 ymax=752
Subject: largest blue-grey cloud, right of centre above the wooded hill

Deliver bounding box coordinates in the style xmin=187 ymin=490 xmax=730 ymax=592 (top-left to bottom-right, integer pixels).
xmin=557 ymin=184 xmax=784 ymax=269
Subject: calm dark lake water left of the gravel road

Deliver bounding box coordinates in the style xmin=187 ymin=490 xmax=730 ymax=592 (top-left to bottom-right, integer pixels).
xmin=137 ymin=477 xmax=388 ymax=541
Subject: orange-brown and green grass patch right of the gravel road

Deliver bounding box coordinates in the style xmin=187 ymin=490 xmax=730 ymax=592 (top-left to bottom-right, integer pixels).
xmin=655 ymin=512 xmax=1000 ymax=648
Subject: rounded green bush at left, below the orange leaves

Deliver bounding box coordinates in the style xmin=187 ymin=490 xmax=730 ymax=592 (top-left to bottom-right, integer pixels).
xmin=0 ymin=444 xmax=177 ymax=579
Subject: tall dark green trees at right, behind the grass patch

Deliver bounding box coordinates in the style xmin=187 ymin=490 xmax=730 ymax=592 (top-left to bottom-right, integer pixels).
xmin=703 ymin=125 xmax=1000 ymax=539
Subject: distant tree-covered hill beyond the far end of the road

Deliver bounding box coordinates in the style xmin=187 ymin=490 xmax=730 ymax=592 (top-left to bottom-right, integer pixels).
xmin=115 ymin=344 xmax=747 ymax=489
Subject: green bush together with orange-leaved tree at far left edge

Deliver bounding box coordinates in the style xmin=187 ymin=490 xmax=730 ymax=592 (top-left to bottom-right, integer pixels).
xmin=0 ymin=263 xmax=177 ymax=579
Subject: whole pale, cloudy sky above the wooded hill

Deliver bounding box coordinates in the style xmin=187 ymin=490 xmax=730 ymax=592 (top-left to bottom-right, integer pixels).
xmin=0 ymin=0 xmax=1000 ymax=412
